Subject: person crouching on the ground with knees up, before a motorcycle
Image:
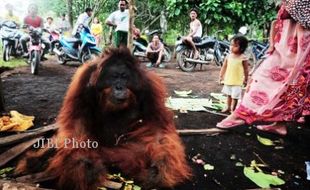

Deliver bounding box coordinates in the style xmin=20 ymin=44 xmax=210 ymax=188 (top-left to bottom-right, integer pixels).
xmin=146 ymin=34 xmax=164 ymax=68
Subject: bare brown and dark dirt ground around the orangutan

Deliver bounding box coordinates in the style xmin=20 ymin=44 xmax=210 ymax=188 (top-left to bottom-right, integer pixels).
xmin=2 ymin=60 xmax=310 ymax=190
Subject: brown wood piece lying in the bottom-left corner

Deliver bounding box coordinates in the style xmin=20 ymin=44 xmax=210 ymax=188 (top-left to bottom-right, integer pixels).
xmin=0 ymin=179 xmax=48 ymax=190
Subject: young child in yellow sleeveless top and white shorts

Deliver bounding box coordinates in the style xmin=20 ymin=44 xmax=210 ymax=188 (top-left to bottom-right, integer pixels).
xmin=220 ymin=35 xmax=248 ymax=112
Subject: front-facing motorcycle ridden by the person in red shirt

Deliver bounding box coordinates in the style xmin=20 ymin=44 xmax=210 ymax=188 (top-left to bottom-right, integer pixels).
xmin=28 ymin=26 xmax=44 ymax=75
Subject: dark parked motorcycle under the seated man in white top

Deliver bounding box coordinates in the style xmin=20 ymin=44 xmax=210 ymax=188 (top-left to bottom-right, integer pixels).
xmin=175 ymin=36 xmax=230 ymax=72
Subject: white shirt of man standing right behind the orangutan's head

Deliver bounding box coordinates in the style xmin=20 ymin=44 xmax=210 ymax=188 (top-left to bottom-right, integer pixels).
xmin=107 ymin=9 xmax=129 ymax=32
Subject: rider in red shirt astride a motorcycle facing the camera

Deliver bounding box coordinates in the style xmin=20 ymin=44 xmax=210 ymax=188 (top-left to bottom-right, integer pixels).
xmin=20 ymin=4 xmax=50 ymax=60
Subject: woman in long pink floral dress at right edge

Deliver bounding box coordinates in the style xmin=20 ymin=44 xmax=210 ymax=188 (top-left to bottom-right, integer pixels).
xmin=217 ymin=0 xmax=310 ymax=135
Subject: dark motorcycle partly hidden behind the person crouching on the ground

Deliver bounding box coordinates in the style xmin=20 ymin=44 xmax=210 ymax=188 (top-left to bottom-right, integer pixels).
xmin=133 ymin=30 xmax=171 ymax=62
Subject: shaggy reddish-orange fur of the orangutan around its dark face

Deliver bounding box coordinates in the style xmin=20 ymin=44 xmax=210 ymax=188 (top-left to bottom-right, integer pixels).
xmin=17 ymin=49 xmax=191 ymax=190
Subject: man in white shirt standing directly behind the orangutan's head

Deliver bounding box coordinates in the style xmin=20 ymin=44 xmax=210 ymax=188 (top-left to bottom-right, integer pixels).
xmin=106 ymin=0 xmax=129 ymax=47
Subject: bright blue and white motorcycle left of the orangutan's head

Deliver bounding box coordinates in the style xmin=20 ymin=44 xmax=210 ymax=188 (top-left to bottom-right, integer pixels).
xmin=53 ymin=25 xmax=101 ymax=65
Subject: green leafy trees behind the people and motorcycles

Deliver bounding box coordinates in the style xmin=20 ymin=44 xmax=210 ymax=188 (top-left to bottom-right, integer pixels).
xmin=34 ymin=0 xmax=276 ymax=40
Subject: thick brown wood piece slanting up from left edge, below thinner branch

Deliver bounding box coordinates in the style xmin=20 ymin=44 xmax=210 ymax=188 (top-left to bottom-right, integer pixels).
xmin=0 ymin=137 xmax=42 ymax=167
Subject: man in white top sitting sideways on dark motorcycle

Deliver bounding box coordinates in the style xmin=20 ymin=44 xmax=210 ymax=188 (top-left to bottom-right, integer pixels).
xmin=183 ymin=8 xmax=202 ymax=59
